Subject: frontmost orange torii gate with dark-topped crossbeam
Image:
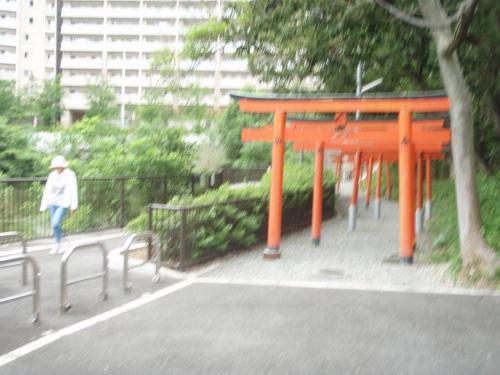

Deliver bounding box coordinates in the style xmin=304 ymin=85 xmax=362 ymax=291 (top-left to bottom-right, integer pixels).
xmin=232 ymin=92 xmax=449 ymax=263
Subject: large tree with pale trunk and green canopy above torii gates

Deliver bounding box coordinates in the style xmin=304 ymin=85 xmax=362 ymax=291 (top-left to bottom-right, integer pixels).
xmin=186 ymin=0 xmax=500 ymax=270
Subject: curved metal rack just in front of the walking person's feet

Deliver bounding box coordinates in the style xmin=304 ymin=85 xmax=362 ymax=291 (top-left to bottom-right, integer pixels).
xmin=60 ymin=241 xmax=108 ymax=313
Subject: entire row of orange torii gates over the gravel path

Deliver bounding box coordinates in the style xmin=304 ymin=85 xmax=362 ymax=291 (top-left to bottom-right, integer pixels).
xmin=232 ymin=92 xmax=450 ymax=264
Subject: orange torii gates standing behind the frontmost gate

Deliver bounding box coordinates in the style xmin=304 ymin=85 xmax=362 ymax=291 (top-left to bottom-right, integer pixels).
xmin=241 ymin=120 xmax=450 ymax=246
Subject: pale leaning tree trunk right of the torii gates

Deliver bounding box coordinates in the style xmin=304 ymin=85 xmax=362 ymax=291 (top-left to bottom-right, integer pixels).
xmin=419 ymin=0 xmax=497 ymax=270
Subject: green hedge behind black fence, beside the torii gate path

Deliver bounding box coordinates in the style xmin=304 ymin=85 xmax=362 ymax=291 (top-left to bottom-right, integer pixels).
xmin=127 ymin=165 xmax=335 ymax=260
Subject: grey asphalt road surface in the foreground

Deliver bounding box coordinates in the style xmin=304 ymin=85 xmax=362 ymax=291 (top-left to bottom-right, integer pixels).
xmin=0 ymin=280 xmax=500 ymax=375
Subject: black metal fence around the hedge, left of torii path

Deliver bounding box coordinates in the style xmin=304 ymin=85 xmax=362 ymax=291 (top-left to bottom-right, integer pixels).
xmin=148 ymin=187 xmax=335 ymax=269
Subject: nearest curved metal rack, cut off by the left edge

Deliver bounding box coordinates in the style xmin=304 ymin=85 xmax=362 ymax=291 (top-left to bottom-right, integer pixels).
xmin=0 ymin=254 xmax=40 ymax=323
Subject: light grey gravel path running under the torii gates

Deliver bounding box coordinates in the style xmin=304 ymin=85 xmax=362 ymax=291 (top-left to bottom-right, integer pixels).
xmin=200 ymin=185 xmax=454 ymax=288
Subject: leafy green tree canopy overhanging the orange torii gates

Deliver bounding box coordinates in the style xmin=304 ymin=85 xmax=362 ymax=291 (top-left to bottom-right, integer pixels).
xmin=189 ymin=0 xmax=500 ymax=170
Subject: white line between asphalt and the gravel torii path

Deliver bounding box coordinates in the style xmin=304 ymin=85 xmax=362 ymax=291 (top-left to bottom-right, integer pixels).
xmin=194 ymin=277 xmax=500 ymax=297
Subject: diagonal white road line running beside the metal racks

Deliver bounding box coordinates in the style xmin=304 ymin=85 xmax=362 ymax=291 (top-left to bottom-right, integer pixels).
xmin=0 ymin=280 xmax=193 ymax=367
